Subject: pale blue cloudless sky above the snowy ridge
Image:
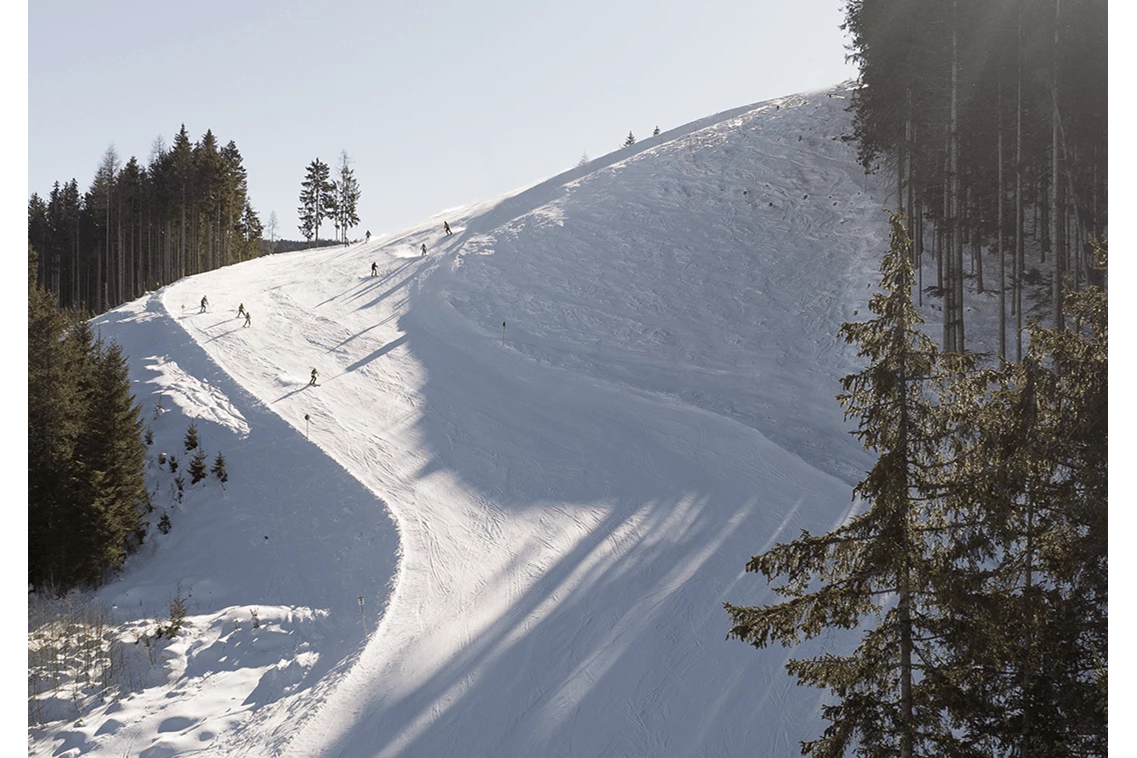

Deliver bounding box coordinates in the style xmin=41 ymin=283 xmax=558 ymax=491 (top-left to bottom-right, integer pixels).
xmin=27 ymin=0 xmax=856 ymax=239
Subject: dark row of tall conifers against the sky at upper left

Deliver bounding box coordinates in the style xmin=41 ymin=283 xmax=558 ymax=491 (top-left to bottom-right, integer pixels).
xmin=27 ymin=125 xmax=263 ymax=313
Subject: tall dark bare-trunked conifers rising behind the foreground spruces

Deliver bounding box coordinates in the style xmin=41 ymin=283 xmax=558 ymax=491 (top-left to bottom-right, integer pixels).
xmin=844 ymin=0 xmax=1109 ymax=359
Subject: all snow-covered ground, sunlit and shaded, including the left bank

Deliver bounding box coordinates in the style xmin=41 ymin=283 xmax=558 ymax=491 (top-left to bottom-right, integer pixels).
xmin=28 ymin=83 xmax=964 ymax=758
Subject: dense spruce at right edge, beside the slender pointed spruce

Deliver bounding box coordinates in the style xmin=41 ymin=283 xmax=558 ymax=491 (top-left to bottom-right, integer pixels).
xmin=943 ymin=268 xmax=1109 ymax=757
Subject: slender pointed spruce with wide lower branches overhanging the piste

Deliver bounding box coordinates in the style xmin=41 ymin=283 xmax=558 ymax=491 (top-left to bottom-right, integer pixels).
xmin=725 ymin=216 xmax=962 ymax=757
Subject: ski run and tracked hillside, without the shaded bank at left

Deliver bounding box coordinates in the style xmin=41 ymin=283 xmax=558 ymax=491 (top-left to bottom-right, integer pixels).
xmin=139 ymin=81 xmax=873 ymax=757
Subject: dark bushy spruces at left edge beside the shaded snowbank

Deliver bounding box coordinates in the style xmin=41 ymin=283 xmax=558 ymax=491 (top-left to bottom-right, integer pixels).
xmin=27 ymin=245 xmax=149 ymax=592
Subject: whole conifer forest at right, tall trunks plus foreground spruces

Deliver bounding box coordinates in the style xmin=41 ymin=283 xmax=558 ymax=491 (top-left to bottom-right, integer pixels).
xmin=724 ymin=0 xmax=1109 ymax=758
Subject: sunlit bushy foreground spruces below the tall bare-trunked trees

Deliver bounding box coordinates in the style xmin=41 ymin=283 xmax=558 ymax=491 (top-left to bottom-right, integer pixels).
xmin=725 ymin=217 xmax=1110 ymax=758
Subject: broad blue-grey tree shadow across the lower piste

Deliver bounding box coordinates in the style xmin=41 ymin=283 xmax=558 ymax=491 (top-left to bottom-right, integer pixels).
xmin=306 ymin=300 xmax=849 ymax=756
